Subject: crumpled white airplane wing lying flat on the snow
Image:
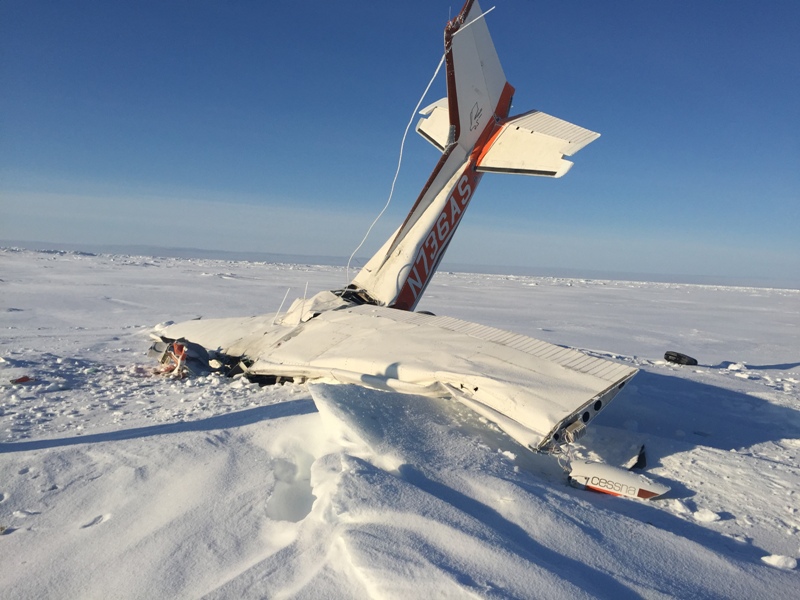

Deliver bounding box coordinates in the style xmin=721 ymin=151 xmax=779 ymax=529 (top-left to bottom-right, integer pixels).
xmin=153 ymin=304 xmax=636 ymax=450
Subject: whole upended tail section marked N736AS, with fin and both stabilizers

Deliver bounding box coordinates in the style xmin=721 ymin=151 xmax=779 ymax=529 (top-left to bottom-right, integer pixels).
xmin=347 ymin=0 xmax=597 ymax=310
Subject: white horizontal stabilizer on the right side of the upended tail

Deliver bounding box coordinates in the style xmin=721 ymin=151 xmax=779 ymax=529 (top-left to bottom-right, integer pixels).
xmin=478 ymin=110 xmax=600 ymax=177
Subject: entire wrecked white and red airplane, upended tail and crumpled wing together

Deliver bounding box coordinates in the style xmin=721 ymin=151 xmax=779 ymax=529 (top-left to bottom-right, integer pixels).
xmin=150 ymin=0 xmax=636 ymax=451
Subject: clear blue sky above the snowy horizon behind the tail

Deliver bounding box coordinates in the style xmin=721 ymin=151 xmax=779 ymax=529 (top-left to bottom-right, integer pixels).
xmin=0 ymin=0 xmax=800 ymax=286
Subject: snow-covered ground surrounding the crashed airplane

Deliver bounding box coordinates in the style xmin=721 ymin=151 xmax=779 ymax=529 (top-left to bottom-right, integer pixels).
xmin=0 ymin=249 xmax=800 ymax=598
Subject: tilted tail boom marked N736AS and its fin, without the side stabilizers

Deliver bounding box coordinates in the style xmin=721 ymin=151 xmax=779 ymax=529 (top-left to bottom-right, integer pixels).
xmin=350 ymin=0 xmax=513 ymax=310
